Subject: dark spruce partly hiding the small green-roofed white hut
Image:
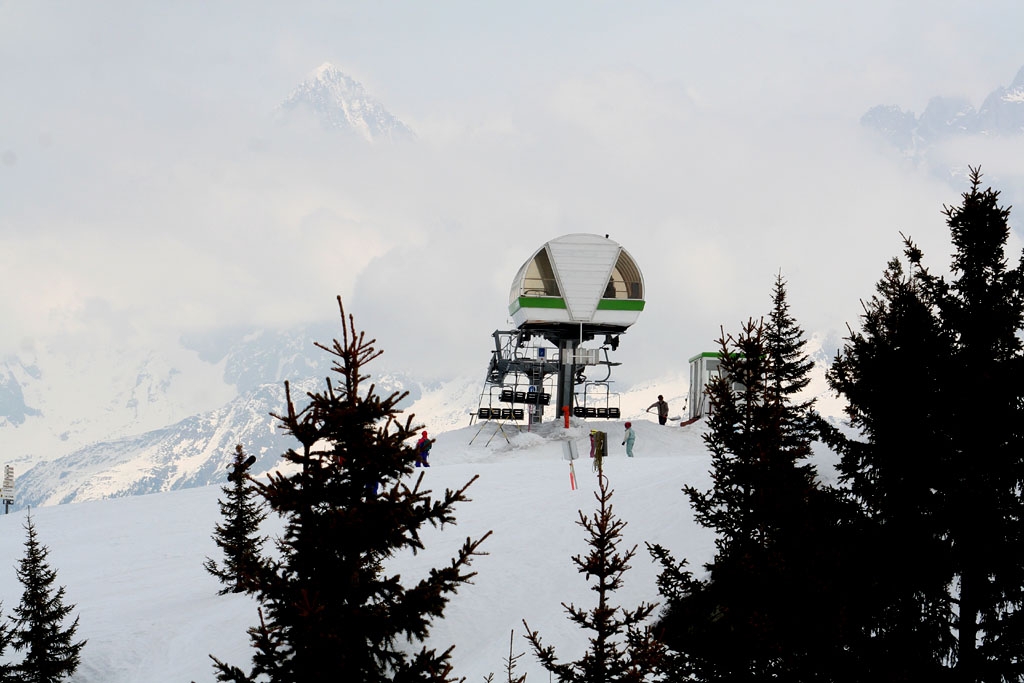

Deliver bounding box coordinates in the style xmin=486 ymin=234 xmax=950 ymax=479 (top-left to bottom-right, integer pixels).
xmin=651 ymin=276 xmax=854 ymax=681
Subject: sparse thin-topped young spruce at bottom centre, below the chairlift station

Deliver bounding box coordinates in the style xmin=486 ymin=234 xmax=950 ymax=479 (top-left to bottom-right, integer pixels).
xmin=523 ymin=458 xmax=664 ymax=683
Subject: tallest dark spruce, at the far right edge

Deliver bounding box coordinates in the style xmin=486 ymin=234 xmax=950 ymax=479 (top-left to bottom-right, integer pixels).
xmin=908 ymin=168 xmax=1024 ymax=681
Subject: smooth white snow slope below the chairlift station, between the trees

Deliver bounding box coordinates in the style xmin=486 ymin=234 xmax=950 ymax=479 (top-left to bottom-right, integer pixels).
xmin=0 ymin=418 xmax=831 ymax=683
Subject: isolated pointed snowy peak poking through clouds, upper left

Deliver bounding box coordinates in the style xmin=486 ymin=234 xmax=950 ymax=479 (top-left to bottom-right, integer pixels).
xmin=280 ymin=62 xmax=416 ymax=142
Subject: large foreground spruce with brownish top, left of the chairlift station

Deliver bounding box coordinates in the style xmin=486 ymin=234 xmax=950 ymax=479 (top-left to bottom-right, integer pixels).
xmin=206 ymin=297 xmax=489 ymax=683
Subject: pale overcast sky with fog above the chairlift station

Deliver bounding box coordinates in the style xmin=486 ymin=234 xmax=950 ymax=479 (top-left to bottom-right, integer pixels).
xmin=0 ymin=0 xmax=1024 ymax=387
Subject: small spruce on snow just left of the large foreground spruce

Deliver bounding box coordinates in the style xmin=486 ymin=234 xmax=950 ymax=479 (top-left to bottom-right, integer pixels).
xmin=203 ymin=443 xmax=266 ymax=595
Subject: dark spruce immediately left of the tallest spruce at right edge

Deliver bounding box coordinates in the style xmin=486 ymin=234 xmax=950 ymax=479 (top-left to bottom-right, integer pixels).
xmin=827 ymin=254 xmax=954 ymax=681
